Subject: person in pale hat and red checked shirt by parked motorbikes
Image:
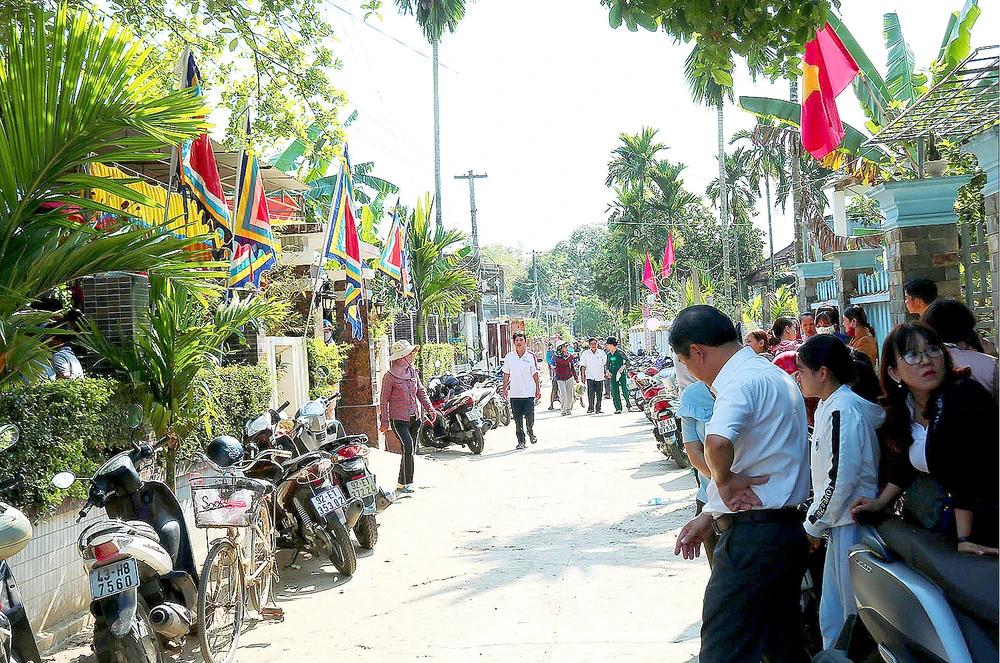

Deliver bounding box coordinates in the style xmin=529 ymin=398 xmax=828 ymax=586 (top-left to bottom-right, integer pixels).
xmin=379 ymin=340 xmax=438 ymax=493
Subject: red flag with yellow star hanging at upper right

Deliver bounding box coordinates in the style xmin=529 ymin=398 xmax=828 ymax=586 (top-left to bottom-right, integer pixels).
xmin=802 ymin=23 xmax=858 ymax=160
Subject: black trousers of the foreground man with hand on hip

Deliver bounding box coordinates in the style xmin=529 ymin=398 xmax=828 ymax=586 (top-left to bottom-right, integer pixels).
xmin=698 ymin=522 xmax=809 ymax=663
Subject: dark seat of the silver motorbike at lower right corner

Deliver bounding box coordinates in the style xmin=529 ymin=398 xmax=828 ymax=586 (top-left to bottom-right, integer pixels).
xmin=877 ymin=518 xmax=1000 ymax=627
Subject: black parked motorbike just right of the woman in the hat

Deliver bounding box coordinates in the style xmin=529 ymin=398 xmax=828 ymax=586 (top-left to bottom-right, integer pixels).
xmin=417 ymin=378 xmax=494 ymax=455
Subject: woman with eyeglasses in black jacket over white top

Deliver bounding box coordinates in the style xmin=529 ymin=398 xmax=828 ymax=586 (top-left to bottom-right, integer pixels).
xmin=852 ymin=322 xmax=1000 ymax=555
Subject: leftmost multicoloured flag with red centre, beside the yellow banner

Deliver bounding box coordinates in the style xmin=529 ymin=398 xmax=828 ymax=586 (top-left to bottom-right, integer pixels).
xmin=174 ymin=46 xmax=233 ymax=248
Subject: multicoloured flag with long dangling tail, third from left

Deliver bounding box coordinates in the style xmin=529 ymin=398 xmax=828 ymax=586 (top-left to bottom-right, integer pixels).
xmin=325 ymin=145 xmax=364 ymax=340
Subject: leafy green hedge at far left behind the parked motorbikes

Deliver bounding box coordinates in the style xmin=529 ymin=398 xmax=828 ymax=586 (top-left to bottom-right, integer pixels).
xmin=0 ymin=378 xmax=130 ymax=511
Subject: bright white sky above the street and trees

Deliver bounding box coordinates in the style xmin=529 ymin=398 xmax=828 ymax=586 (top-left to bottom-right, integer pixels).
xmin=318 ymin=0 xmax=1000 ymax=253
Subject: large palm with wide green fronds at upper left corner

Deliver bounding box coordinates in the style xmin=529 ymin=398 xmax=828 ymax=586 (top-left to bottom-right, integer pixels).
xmin=0 ymin=5 xmax=220 ymax=390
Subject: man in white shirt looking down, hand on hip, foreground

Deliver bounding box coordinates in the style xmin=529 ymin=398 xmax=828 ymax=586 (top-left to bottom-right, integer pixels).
xmin=670 ymin=306 xmax=809 ymax=663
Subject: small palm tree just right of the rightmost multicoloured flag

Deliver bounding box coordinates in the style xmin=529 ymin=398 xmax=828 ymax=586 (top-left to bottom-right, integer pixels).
xmin=407 ymin=193 xmax=478 ymax=344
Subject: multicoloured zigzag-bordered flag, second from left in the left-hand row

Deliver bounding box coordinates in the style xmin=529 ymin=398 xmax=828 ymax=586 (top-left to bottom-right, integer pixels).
xmin=231 ymin=119 xmax=278 ymax=287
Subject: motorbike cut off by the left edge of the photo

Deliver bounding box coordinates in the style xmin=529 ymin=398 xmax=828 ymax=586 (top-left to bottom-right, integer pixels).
xmin=0 ymin=424 xmax=42 ymax=663
